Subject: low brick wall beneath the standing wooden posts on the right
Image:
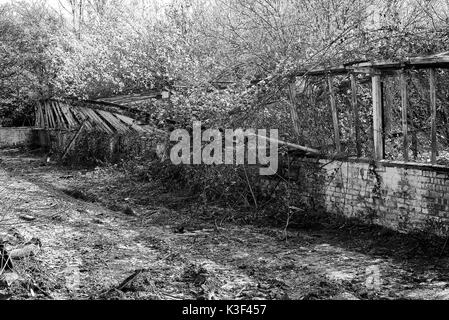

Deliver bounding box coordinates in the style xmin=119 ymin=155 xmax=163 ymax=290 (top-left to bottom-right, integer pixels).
xmin=265 ymin=158 xmax=449 ymax=234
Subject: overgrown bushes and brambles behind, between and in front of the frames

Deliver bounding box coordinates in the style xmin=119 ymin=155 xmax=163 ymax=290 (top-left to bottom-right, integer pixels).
xmin=0 ymin=0 xmax=449 ymax=230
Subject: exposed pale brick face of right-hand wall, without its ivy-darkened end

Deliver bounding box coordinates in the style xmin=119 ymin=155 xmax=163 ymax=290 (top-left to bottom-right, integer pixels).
xmin=260 ymin=160 xmax=449 ymax=235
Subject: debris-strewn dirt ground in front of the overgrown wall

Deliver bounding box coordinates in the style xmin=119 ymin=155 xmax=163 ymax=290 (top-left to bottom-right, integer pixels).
xmin=0 ymin=150 xmax=449 ymax=300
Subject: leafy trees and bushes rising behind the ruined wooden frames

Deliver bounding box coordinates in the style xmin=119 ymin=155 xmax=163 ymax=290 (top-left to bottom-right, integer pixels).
xmin=0 ymin=0 xmax=448 ymax=136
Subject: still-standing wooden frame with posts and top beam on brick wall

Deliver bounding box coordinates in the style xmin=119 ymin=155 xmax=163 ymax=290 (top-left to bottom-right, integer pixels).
xmin=292 ymin=52 xmax=449 ymax=164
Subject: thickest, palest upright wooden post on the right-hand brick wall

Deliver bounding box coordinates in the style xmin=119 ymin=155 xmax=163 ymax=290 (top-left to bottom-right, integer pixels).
xmin=372 ymin=74 xmax=384 ymax=160
